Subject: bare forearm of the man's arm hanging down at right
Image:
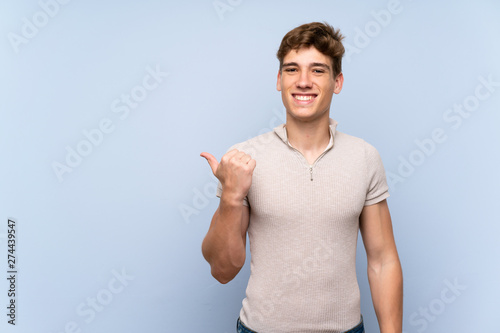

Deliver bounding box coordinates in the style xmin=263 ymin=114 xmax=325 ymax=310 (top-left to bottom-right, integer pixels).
xmin=368 ymin=257 xmax=403 ymax=333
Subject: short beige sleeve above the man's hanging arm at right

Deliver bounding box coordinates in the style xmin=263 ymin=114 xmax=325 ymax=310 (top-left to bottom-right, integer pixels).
xmin=365 ymin=143 xmax=389 ymax=206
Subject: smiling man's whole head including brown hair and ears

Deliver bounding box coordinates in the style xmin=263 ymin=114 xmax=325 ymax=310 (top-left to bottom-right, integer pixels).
xmin=276 ymin=23 xmax=344 ymax=123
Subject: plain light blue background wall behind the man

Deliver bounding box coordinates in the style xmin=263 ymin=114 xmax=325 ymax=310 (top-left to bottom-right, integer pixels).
xmin=0 ymin=0 xmax=500 ymax=333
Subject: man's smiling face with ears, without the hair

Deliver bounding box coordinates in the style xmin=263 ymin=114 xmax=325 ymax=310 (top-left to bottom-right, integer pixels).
xmin=276 ymin=46 xmax=344 ymax=121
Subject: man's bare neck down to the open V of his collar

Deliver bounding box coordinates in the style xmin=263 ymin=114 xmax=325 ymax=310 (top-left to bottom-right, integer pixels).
xmin=286 ymin=115 xmax=330 ymax=164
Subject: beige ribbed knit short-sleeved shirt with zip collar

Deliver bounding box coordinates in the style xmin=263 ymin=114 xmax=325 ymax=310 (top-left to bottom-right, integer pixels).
xmin=217 ymin=119 xmax=389 ymax=333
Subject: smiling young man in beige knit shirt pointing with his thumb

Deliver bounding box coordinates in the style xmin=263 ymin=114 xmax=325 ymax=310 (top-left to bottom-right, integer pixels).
xmin=201 ymin=23 xmax=403 ymax=333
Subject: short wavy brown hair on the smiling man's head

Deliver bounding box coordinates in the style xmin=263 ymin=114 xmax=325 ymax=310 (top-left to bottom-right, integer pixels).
xmin=276 ymin=22 xmax=345 ymax=77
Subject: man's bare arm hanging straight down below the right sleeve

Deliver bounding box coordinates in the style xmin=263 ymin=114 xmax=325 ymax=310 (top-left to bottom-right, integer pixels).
xmin=360 ymin=200 xmax=403 ymax=333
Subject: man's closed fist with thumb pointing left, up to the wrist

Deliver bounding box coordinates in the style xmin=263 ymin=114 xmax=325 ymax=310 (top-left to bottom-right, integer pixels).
xmin=200 ymin=149 xmax=256 ymax=201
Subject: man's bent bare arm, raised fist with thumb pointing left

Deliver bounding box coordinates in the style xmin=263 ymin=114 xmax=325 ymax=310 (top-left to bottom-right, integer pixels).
xmin=201 ymin=149 xmax=256 ymax=283
